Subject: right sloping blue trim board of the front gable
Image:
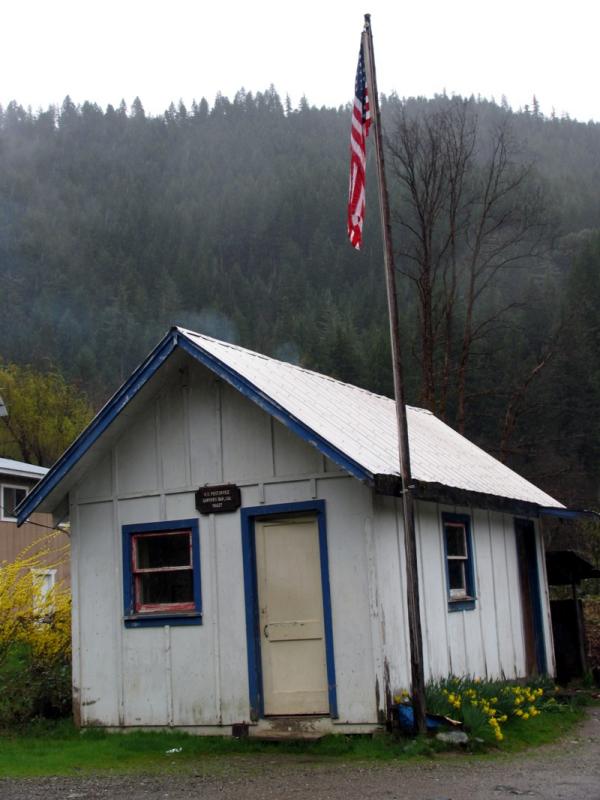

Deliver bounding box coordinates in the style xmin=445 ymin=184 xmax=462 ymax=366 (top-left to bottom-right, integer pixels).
xmin=177 ymin=333 xmax=373 ymax=483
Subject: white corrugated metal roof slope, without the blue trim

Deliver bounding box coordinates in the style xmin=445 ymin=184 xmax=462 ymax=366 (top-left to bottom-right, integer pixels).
xmin=179 ymin=329 xmax=562 ymax=508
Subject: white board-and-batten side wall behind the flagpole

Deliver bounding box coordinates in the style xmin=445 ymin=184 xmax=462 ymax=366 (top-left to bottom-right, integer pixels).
xmin=375 ymin=498 xmax=554 ymax=694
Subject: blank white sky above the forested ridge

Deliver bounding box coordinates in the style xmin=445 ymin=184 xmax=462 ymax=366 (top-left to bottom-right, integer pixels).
xmin=0 ymin=0 xmax=600 ymax=121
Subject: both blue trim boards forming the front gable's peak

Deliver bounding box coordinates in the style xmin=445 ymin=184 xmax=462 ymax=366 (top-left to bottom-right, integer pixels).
xmin=17 ymin=328 xmax=373 ymax=525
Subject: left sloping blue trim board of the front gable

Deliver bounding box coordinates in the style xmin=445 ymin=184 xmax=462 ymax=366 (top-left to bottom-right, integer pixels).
xmin=17 ymin=329 xmax=177 ymax=525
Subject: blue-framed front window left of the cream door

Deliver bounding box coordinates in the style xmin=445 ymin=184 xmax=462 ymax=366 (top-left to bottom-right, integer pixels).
xmin=123 ymin=519 xmax=202 ymax=627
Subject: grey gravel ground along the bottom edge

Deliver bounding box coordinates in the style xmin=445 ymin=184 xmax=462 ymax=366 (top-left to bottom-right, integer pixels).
xmin=0 ymin=708 xmax=600 ymax=800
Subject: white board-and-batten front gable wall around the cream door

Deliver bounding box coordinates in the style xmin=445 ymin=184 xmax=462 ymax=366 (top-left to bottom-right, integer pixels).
xmin=70 ymin=364 xmax=377 ymax=728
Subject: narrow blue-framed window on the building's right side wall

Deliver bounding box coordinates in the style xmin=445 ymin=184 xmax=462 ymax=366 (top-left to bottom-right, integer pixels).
xmin=442 ymin=514 xmax=475 ymax=611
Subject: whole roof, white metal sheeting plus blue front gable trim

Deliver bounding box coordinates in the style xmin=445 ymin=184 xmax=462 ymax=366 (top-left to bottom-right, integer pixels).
xmin=17 ymin=328 xmax=564 ymax=524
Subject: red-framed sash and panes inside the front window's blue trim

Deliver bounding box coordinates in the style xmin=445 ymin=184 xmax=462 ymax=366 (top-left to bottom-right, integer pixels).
xmin=131 ymin=530 xmax=195 ymax=613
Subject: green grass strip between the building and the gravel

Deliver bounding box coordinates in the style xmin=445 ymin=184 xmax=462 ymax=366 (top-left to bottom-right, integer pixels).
xmin=0 ymin=705 xmax=583 ymax=778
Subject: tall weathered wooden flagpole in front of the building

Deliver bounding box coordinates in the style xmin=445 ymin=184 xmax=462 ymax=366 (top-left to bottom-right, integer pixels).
xmin=363 ymin=14 xmax=426 ymax=733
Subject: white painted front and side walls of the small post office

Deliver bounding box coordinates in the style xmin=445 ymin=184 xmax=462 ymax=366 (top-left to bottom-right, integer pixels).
xmin=70 ymin=354 xmax=551 ymax=726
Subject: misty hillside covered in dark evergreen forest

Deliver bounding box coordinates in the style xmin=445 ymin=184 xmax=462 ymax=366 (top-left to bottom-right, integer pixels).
xmin=0 ymin=89 xmax=600 ymax=505
